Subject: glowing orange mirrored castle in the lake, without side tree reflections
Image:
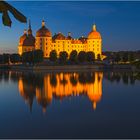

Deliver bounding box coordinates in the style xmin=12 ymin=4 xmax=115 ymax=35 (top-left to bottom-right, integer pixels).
xmin=18 ymin=72 xmax=103 ymax=112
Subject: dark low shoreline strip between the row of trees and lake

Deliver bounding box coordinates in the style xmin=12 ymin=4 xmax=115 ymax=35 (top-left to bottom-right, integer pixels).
xmin=0 ymin=64 xmax=140 ymax=72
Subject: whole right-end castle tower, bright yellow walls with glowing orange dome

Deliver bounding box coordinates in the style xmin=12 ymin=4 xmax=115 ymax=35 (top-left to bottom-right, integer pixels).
xmin=86 ymin=24 xmax=102 ymax=59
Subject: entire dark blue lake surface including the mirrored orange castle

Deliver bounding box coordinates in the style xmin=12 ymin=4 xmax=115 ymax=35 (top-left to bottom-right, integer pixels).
xmin=0 ymin=71 xmax=140 ymax=138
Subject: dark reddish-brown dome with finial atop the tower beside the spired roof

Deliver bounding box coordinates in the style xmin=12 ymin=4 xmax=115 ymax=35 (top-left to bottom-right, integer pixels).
xmin=36 ymin=20 xmax=52 ymax=37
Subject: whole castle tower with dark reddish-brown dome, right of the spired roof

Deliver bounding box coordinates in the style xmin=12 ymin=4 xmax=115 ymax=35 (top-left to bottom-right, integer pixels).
xmin=35 ymin=20 xmax=52 ymax=57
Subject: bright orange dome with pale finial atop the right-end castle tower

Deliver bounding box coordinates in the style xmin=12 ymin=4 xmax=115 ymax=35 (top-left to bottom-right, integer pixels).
xmin=88 ymin=24 xmax=101 ymax=39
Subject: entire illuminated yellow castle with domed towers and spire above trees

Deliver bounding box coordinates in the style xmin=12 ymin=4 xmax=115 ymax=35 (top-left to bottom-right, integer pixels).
xmin=18 ymin=20 xmax=105 ymax=60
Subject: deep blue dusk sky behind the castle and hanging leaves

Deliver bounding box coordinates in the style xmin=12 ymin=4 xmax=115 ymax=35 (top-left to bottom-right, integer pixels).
xmin=0 ymin=1 xmax=140 ymax=53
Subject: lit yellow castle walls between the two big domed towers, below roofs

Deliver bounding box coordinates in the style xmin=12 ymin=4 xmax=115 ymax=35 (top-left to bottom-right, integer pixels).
xmin=36 ymin=37 xmax=102 ymax=58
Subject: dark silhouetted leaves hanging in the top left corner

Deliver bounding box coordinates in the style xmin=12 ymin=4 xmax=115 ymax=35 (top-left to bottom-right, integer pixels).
xmin=0 ymin=1 xmax=27 ymax=26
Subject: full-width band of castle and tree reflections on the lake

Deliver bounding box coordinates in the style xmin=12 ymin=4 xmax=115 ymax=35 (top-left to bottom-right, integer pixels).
xmin=0 ymin=71 xmax=140 ymax=112
